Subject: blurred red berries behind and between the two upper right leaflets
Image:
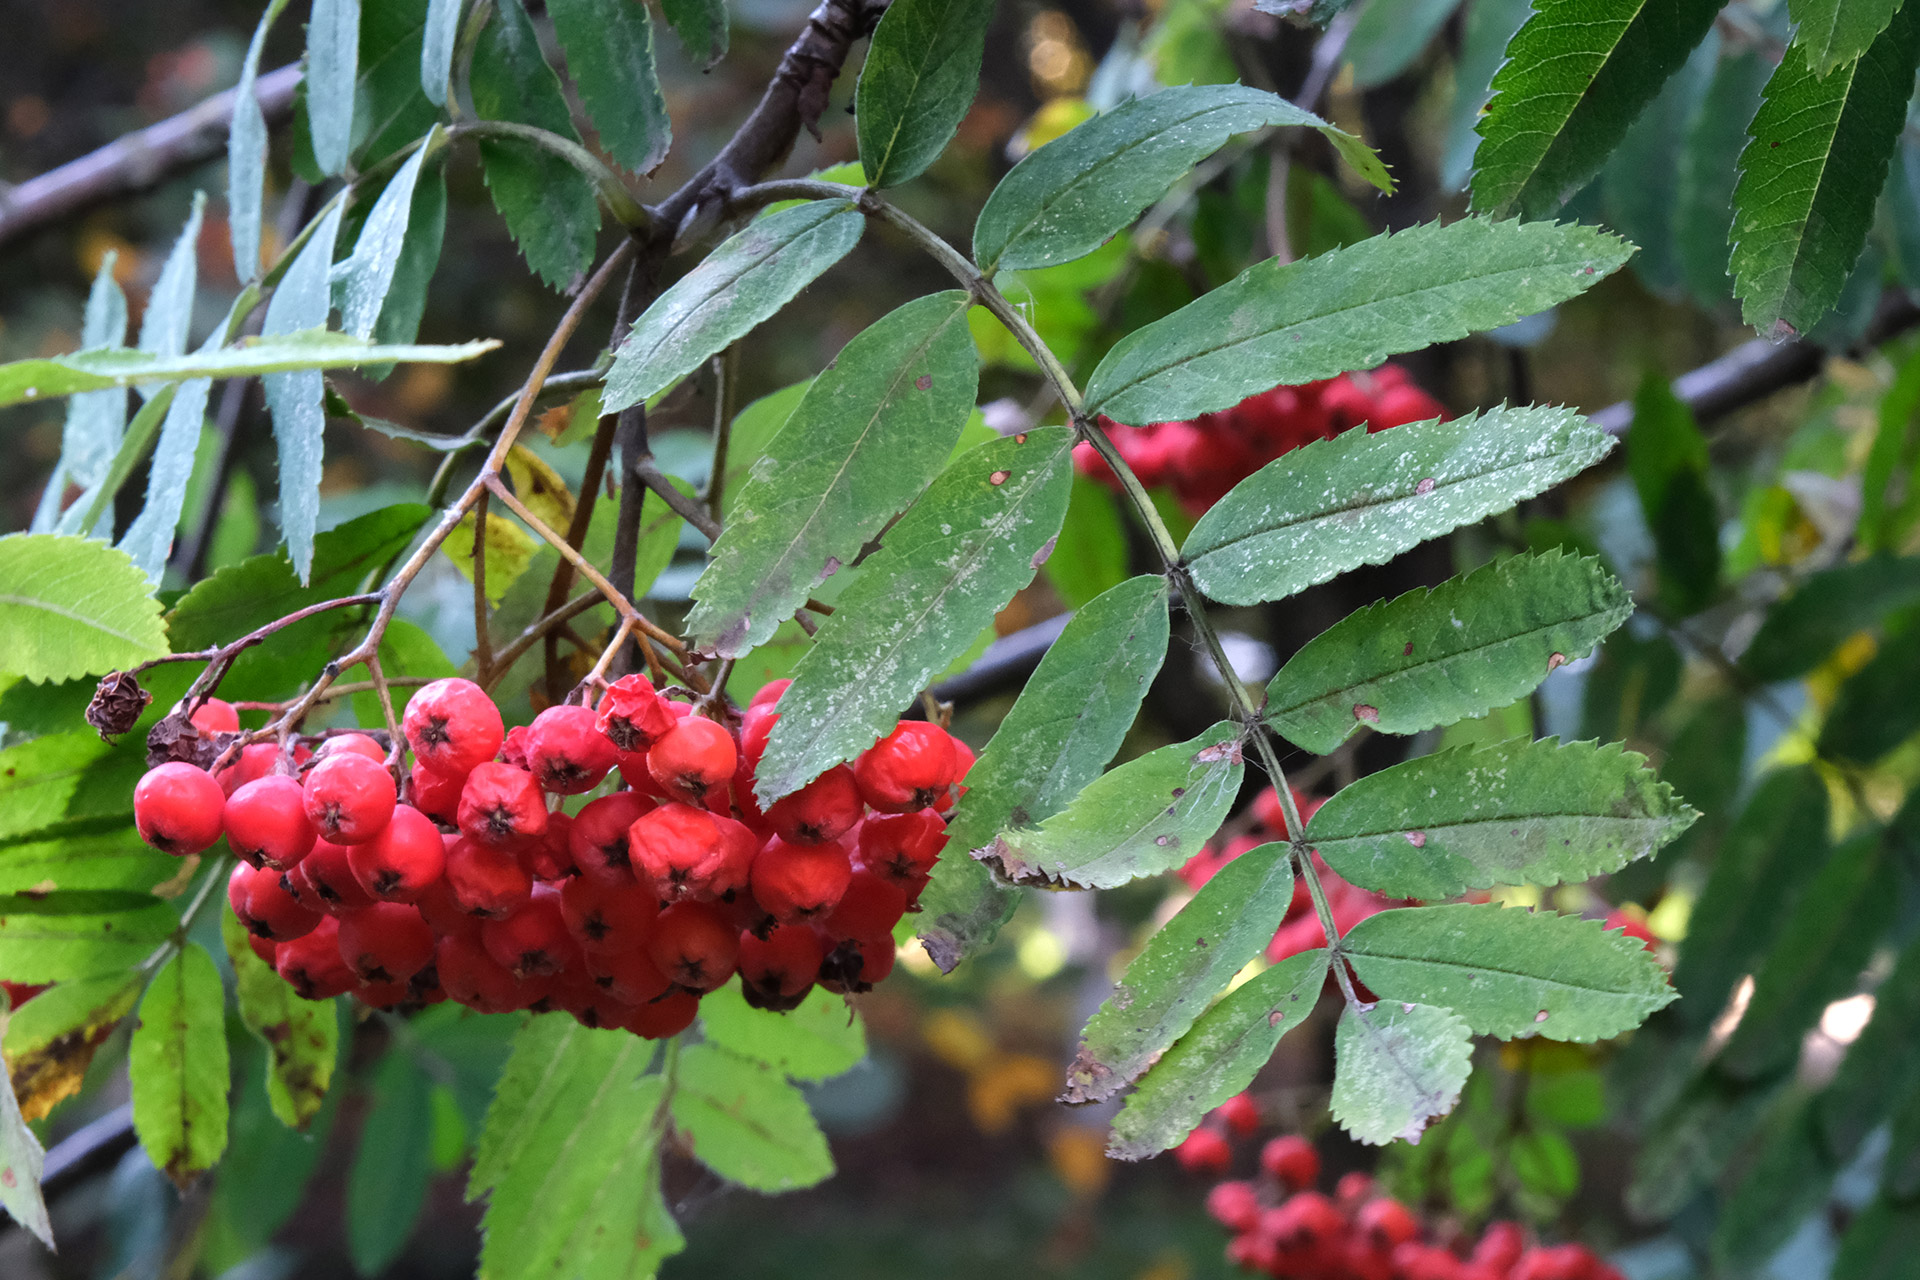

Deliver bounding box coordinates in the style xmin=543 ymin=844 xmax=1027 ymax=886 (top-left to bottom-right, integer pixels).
xmin=1073 ymin=365 xmax=1446 ymax=516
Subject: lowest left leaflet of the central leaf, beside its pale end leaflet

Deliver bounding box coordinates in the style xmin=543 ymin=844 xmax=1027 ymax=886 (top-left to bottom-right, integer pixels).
xmin=1106 ymin=950 xmax=1327 ymax=1159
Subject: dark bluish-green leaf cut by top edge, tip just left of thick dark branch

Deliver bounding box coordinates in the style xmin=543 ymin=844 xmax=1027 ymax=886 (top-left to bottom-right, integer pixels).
xmin=547 ymin=0 xmax=674 ymax=173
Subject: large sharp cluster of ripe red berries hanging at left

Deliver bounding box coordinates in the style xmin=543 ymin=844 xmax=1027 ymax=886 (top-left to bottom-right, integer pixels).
xmin=134 ymin=676 xmax=973 ymax=1036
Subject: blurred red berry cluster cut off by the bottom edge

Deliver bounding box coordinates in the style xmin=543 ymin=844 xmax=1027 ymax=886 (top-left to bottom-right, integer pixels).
xmin=1173 ymin=1094 xmax=1620 ymax=1280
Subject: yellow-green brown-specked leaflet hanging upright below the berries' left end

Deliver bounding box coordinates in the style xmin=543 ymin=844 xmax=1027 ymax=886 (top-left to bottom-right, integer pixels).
xmin=127 ymin=942 xmax=228 ymax=1188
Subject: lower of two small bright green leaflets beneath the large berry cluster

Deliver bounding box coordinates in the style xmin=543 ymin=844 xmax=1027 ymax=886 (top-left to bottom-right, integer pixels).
xmin=670 ymin=1044 xmax=833 ymax=1192
